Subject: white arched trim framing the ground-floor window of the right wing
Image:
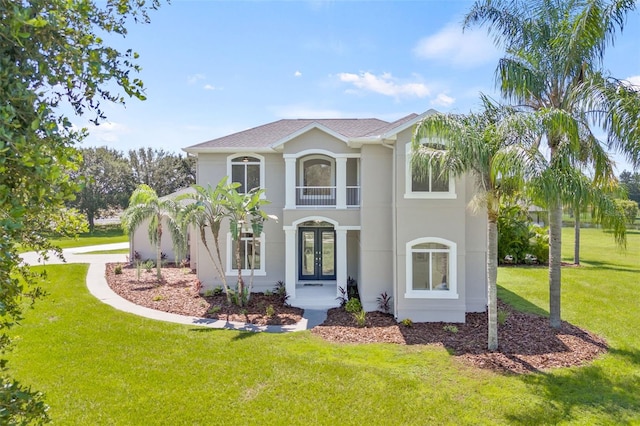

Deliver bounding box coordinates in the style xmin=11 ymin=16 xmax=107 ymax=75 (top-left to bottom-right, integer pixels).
xmin=404 ymin=237 xmax=459 ymax=299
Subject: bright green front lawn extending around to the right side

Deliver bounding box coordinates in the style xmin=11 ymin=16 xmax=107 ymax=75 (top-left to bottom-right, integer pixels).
xmin=9 ymin=230 xmax=640 ymax=425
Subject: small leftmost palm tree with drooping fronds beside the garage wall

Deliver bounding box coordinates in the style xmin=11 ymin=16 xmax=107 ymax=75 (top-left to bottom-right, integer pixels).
xmin=122 ymin=184 xmax=187 ymax=281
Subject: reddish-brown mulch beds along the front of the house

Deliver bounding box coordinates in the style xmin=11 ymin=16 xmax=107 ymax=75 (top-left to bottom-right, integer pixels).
xmin=106 ymin=264 xmax=607 ymax=374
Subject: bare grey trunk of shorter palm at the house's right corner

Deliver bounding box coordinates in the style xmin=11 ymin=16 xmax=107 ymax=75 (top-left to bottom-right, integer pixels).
xmin=487 ymin=212 xmax=498 ymax=351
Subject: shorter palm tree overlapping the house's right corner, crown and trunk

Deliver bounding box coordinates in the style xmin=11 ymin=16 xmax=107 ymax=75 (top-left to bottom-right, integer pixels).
xmin=412 ymin=97 xmax=540 ymax=351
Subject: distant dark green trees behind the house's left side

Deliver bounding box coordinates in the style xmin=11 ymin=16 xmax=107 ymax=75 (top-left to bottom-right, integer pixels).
xmin=67 ymin=146 xmax=196 ymax=231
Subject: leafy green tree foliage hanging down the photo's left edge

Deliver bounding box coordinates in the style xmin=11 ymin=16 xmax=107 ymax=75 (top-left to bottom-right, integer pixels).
xmin=0 ymin=0 xmax=158 ymax=424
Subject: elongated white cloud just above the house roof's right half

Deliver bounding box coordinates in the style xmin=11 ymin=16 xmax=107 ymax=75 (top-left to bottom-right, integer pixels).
xmin=337 ymin=72 xmax=431 ymax=98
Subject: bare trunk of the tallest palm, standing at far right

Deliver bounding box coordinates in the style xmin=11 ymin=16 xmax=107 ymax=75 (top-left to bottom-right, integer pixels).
xmin=549 ymin=201 xmax=562 ymax=328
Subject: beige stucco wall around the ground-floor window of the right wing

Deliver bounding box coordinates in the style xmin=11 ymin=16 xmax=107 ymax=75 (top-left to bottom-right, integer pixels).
xmin=395 ymin=130 xmax=486 ymax=322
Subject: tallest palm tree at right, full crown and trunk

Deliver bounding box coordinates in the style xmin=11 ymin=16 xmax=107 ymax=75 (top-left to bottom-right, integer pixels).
xmin=464 ymin=0 xmax=640 ymax=328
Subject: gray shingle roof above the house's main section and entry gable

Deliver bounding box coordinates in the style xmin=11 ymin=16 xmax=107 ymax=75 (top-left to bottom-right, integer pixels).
xmin=187 ymin=114 xmax=396 ymax=149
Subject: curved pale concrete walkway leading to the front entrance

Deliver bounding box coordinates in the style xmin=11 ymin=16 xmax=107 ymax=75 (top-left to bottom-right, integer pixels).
xmin=21 ymin=243 xmax=327 ymax=333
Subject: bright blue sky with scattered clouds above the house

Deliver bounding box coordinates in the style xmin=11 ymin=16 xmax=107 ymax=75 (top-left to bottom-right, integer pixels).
xmin=75 ymin=0 xmax=640 ymax=171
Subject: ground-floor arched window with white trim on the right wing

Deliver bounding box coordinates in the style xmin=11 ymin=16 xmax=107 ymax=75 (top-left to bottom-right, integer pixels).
xmin=405 ymin=238 xmax=458 ymax=299
